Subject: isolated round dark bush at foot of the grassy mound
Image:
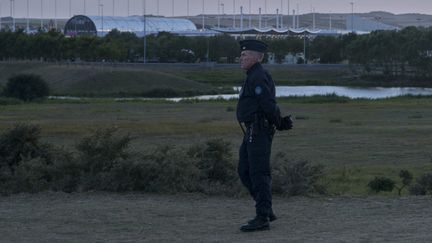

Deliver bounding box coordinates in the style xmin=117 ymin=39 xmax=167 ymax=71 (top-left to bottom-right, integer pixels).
xmin=4 ymin=74 xmax=49 ymax=101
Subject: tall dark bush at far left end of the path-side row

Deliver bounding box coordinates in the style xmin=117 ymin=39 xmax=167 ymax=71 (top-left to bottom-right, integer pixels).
xmin=0 ymin=124 xmax=64 ymax=194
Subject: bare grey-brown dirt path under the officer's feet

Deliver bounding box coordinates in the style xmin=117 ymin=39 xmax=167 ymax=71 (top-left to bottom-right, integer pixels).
xmin=0 ymin=193 xmax=432 ymax=242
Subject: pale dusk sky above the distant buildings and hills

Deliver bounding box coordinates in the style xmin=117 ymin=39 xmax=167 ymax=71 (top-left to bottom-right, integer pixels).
xmin=0 ymin=0 xmax=432 ymax=18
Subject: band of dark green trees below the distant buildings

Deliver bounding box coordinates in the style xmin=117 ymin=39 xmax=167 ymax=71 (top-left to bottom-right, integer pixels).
xmin=0 ymin=27 xmax=432 ymax=78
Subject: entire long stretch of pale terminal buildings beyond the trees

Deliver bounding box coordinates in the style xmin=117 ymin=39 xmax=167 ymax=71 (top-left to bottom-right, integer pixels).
xmin=64 ymin=15 xmax=399 ymax=37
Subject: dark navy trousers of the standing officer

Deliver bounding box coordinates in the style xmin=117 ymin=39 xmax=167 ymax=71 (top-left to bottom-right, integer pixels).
xmin=238 ymin=123 xmax=273 ymax=217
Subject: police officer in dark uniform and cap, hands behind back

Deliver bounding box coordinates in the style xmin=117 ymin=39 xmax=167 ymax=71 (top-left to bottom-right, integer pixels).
xmin=237 ymin=40 xmax=292 ymax=232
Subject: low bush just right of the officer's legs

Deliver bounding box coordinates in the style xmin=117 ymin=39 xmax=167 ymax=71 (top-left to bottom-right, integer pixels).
xmin=273 ymin=153 xmax=326 ymax=196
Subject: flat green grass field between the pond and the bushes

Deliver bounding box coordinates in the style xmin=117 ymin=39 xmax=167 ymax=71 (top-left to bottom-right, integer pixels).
xmin=0 ymin=97 xmax=432 ymax=195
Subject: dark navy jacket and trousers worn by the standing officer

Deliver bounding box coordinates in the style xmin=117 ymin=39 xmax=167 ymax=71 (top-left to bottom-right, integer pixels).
xmin=237 ymin=63 xmax=280 ymax=218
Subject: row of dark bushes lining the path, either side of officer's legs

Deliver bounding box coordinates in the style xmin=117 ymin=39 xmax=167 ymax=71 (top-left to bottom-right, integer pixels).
xmin=0 ymin=124 xmax=325 ymax=195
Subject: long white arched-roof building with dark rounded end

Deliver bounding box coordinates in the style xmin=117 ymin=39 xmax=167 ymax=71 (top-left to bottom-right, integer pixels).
xmin=64 ymin=15 xmax=215 ymax=37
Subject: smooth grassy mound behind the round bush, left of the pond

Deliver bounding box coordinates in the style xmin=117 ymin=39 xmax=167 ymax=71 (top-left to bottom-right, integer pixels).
xmin=0 ymin=62 xmax=216 ymax=96
